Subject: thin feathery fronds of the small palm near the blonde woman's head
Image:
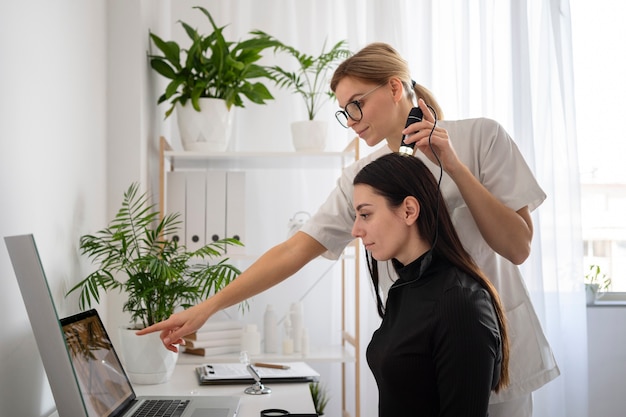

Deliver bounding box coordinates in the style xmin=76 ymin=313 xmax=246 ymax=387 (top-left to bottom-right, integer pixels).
xmin=251 ymin=31 xmax=352 ymax=120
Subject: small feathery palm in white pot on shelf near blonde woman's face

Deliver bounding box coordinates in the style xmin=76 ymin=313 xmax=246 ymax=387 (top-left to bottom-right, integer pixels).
xmin=252 ymin=31 xmax=352 ymax=151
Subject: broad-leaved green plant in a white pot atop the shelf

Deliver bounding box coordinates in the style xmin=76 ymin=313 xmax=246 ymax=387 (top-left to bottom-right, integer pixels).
xmin=148 ymin=6 xmax=277 ymax=152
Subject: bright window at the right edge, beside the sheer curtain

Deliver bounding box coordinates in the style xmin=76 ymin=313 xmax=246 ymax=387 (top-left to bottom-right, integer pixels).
xmin=570 ymin=0 xmax=626 ymax=292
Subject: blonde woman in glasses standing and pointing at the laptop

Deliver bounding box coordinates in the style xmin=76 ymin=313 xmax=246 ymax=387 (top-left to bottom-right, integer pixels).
xmin=140 ymin=43 xmax=559 ymax=417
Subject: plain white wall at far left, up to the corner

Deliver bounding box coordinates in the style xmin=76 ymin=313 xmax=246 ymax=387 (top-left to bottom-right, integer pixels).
xmin=0 ymin=0 xmax=107 ymax=416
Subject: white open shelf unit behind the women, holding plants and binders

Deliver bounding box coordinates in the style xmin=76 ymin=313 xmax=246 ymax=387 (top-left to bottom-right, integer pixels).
xmin=159 ymin=137 xmax=361 ymax=417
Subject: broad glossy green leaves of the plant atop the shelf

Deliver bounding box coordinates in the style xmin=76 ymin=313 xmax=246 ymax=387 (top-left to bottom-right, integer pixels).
xmin=149 ymin=6 xmax=278 ymax=118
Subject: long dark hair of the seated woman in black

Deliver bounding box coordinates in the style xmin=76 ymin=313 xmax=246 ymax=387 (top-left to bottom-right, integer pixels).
xmin=353 ymin=153 xmax=509 ymax=392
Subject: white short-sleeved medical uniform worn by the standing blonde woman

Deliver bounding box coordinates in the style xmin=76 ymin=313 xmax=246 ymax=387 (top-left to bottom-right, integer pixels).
xmin=301 ymin=118 xmax=560 ymax=403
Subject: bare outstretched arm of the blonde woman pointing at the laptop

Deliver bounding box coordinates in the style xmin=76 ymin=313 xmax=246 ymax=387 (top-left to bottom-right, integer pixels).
xmin=137 ymin=232 xmax=326 ymax=352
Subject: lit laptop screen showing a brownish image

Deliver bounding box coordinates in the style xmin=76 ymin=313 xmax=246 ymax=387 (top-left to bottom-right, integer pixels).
xmin=61 ymin=309 xmax=135 ymax=417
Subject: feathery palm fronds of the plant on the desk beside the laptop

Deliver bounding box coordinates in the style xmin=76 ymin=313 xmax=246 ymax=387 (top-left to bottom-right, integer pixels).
xmin=67 ymin=183 xmax=242 ymax=326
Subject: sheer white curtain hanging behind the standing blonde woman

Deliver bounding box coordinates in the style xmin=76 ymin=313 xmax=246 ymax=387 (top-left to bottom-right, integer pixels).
xmin=171 ymin=0 xmax=587 ymax=417
